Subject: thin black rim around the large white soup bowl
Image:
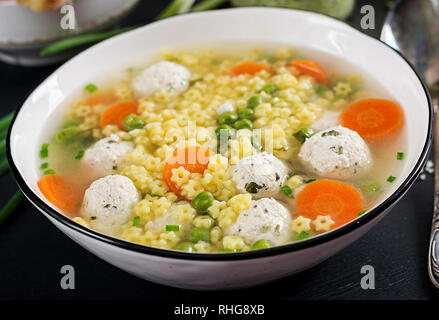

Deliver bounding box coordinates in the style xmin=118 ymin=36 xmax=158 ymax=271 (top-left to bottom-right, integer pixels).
xmin=6 ymin=9 xmax=433 ymax=261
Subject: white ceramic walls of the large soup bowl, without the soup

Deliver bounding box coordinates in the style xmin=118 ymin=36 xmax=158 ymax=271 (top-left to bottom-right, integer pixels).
xmin=8 ymin=8 xmax=432 ymax=290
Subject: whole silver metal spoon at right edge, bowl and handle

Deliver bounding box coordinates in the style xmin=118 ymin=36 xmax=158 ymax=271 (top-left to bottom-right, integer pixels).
xmin=381 ymin=0 xmax=439 ymax=288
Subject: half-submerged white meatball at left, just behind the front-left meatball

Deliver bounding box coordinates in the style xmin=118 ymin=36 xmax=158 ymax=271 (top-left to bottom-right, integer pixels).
xmin=82 ymin=135 xmax=133 ymax=177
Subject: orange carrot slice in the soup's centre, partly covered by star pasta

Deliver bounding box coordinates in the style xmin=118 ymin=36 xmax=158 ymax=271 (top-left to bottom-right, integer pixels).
xmin=163 ymin=146 xmax=215 ymax=195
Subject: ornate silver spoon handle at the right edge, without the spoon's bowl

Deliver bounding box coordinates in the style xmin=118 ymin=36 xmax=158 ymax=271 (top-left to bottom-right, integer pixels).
xmin=428 ymin=100 xmax=439 ymax=289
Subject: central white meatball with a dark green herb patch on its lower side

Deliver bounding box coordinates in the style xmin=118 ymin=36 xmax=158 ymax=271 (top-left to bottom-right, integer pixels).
xmin=232 ymin=152 xmax=289 ymax=198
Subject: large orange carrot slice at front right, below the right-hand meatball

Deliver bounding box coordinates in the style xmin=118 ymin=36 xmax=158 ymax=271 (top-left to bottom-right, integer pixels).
xmin=296 ymin=179 xmax=363 ymax=228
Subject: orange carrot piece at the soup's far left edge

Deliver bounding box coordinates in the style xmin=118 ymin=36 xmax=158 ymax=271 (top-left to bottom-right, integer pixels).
xmin=38 ymin=174 xmax=84 ymax=215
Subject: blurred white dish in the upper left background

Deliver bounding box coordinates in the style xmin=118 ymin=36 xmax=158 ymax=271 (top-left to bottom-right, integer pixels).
xmin=0 ymin=0 xmax=139 ymax=66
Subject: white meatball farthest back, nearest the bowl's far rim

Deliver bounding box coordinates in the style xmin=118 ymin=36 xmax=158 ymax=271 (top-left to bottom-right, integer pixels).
xmin=132 ymin=61 xmax=191 ymax=96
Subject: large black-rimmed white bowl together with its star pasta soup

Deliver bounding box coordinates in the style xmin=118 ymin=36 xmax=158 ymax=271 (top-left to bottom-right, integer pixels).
xmin=10 ymin=9 xmax=431 ymax=289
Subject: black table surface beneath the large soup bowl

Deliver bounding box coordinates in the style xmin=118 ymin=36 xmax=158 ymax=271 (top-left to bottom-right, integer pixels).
xmin=0 ymin=0 xmax=439 ymax=303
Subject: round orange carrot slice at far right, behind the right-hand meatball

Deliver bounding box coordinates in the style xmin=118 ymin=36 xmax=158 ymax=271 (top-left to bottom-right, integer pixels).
xmin=340 ymin=99 xmax=404 ymax=139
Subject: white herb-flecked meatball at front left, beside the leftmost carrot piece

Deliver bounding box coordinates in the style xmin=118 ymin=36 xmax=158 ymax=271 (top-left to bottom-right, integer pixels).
xmin=81 ymin=175 xmax=139 ymax=235
